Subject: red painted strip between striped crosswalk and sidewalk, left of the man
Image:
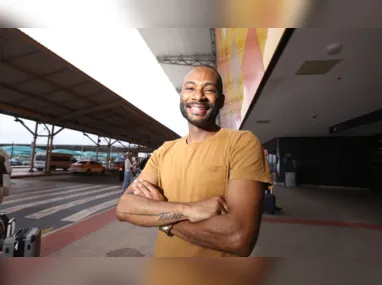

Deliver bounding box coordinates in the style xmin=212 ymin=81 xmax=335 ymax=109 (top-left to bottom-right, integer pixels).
xmin=41 ymin=207 xmax=117 ymax=254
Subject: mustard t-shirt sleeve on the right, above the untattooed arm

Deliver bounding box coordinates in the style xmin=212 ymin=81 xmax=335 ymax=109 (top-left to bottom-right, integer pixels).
xmin=229 ymin=132 xmax=272 ymax=184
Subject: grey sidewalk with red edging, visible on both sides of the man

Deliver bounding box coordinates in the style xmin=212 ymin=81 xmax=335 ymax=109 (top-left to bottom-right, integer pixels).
xmin=42 ymin=186 xmax=382 ymax=257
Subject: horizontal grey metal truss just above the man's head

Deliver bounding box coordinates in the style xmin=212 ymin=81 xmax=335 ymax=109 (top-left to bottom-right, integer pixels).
xmin=157 ymin=54 xmax=216 ymax=67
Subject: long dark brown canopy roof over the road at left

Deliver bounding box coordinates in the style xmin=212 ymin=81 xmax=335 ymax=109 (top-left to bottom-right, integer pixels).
xmin=0 ymin=28 xmax=179 ymax=148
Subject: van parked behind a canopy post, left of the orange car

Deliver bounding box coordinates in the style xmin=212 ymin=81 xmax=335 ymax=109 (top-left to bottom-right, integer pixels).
xmin=34 ymin=152 xmax=76 ymax=171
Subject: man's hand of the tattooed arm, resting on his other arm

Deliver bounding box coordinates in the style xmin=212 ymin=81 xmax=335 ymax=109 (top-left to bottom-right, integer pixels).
xmin=185 ymin=196 xmax=228 ymax=223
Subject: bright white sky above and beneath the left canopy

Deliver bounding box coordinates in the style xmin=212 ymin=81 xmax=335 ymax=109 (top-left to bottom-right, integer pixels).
xmin=0 ymin=27 xmax=187 ymax=145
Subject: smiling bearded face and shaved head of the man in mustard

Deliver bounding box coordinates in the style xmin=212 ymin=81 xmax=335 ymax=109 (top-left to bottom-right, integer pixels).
xmin=180 ymin=67 xmax=224 ymax=128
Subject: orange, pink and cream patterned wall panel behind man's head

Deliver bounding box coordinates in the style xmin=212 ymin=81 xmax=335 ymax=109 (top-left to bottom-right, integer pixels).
xmin=216 ymin=28 xmax=284 ymax=129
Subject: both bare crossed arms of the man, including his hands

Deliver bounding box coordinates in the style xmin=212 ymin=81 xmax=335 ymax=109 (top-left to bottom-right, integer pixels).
xmin=117 ymin=174 xmax=264 ymax=256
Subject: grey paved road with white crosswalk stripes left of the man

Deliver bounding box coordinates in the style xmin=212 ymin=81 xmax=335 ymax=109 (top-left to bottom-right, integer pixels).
xmin=0 ymin=174 xmax=122 ymax=233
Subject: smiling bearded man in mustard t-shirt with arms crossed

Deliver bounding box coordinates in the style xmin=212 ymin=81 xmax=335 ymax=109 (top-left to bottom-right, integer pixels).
xmin=117 ymin=66 xmax=272 ymax=257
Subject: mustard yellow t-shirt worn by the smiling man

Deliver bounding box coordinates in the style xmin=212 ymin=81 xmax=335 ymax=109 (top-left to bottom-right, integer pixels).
xmin=143 ymin=128 xmax=271 ymax=257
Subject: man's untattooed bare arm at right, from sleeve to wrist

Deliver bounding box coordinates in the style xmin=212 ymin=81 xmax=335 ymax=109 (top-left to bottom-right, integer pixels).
xmin=171 ymin=180 xmax=264 ymax=256
